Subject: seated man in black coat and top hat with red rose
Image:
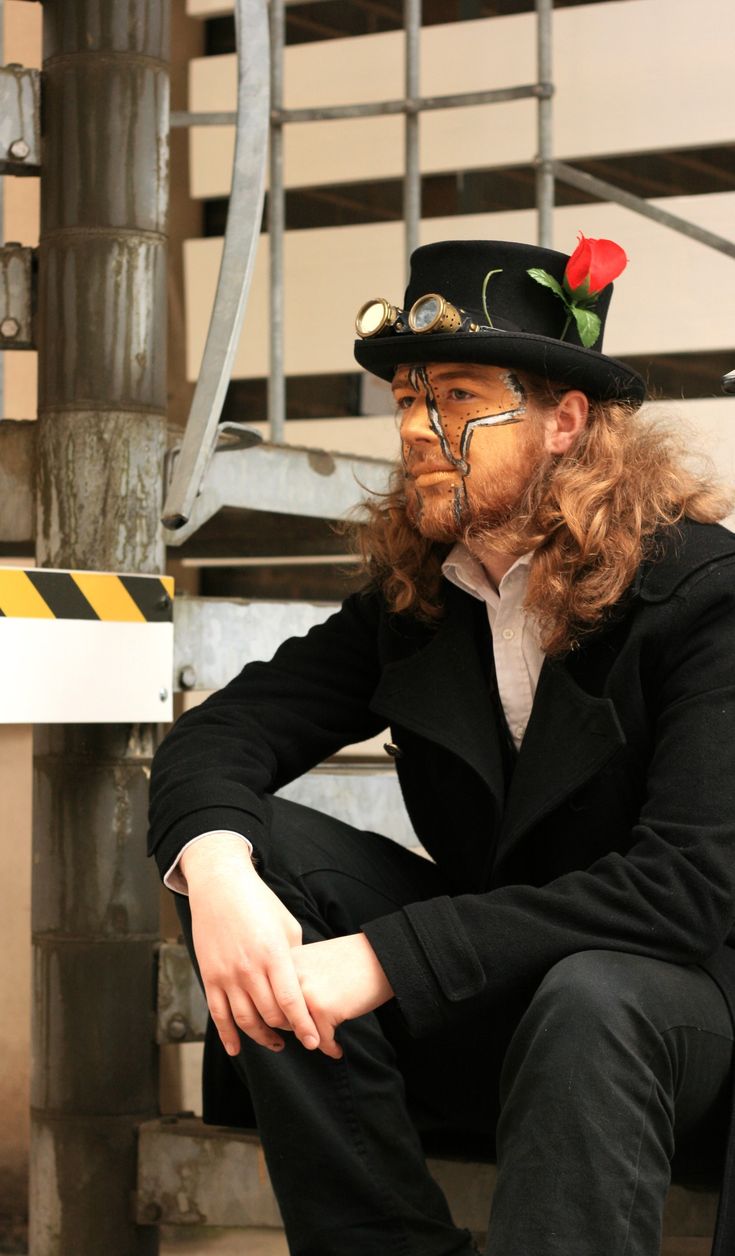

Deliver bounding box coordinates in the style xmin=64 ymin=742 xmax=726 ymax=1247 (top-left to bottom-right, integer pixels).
xmin=151 ymin=239 xmax=735 ymax=1256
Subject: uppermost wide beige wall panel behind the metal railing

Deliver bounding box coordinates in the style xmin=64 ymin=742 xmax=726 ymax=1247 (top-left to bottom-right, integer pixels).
xmin=190 ymin=0 xmax=732 ymax=196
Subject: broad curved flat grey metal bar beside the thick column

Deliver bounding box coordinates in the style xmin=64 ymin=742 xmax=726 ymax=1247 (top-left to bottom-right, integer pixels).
xmin=163 ymin=0 xmax=270 ymax=529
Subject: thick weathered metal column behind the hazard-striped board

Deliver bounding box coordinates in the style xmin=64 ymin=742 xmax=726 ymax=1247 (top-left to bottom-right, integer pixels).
xmin=30 ymin=0 xmax=168 ymax=1256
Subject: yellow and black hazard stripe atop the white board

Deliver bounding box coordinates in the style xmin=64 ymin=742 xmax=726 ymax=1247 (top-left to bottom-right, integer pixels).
xmin=0 ymin=566 xmax=173 ymax=623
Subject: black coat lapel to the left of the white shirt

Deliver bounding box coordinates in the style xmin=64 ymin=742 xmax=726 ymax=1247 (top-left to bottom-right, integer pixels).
xmin=371 ymin=585 xmax=505 ymax=814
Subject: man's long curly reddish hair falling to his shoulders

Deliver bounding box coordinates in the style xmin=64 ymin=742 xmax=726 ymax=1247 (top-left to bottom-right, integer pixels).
xmin=356 ymin=374 xmax=732 ymax=656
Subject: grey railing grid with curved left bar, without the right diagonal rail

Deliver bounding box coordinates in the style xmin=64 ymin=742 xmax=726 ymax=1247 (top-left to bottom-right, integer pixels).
xmin=163 ymin=0 xmax=554 ymax=529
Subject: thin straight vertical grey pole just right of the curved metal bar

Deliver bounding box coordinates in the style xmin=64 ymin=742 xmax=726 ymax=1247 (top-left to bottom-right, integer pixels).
xmin=268 ymin=0 xmax=285 ymax=441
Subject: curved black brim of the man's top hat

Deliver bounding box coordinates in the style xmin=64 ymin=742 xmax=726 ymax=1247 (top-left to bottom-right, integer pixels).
xmin=354 ymin=329 xmax=646 ymax=406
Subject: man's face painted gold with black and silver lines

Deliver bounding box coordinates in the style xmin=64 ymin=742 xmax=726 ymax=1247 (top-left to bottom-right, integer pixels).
xmin=393 ymin=363 xmax=537 ymax=539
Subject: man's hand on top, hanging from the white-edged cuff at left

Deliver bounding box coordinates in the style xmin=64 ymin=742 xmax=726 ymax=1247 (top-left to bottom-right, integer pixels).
xmin=181 ymin=833 xmax=319 ymax=1055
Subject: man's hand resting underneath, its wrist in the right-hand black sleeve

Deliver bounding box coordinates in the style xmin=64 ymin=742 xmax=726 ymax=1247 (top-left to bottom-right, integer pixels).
xmin=293 ymin=933 xmax=393 ymax=1060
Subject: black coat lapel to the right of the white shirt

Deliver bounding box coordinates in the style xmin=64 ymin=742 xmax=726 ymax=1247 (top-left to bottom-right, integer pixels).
xmin=499 ymin=659 xmax=626 ymax=858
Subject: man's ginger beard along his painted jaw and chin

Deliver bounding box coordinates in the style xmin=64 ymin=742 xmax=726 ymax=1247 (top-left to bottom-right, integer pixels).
xmin=406 ymin=423 xmax=548 ymax=544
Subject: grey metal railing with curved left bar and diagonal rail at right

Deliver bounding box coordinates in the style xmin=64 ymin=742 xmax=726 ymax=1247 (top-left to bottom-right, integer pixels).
xmin=165 ymin=0 xmax=735 ymax=528
